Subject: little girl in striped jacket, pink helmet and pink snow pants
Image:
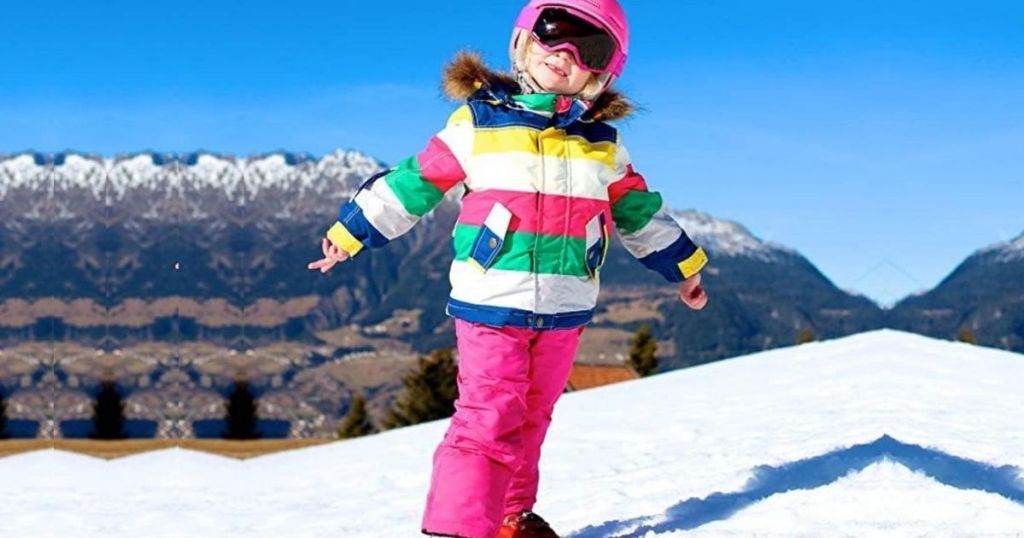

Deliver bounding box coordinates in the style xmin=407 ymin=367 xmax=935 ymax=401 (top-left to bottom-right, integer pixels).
xmin=308 ymin=0 xmax=708 ymax=538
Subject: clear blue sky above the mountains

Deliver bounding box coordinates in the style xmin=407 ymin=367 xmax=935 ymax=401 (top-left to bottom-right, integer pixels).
xmin=0 ymin=0 xmax=1024 ymax=302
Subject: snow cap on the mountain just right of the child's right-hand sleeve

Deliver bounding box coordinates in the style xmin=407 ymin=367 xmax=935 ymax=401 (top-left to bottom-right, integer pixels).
xmin=673 ymin=210 xmax=797 ymax=261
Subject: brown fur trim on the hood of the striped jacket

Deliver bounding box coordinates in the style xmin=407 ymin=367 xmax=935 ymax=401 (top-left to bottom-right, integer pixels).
xmin=442 ymin=51 xmax=636 ymax=122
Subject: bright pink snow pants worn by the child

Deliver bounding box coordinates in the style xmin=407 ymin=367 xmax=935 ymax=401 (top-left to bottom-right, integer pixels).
xmin=422 ymin=320 xmax=583 ymax=538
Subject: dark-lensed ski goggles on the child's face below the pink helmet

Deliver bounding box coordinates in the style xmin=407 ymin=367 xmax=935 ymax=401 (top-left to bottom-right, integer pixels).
xmin=532 ymin=8 xmax=622 ymax=73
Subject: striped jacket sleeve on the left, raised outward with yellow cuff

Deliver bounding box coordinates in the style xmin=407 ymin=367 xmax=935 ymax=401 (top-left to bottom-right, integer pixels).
xmin=327 ymin=106 xmax=473 ymax=256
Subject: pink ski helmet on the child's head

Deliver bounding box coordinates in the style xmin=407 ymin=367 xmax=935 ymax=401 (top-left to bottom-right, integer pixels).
xmin=509 ymin=0 xmax=630 ymax=97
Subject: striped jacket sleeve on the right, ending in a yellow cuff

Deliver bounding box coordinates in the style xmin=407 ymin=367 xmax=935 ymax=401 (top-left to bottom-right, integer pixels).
xmin=608 ymin=138 xmax=708 ymax=282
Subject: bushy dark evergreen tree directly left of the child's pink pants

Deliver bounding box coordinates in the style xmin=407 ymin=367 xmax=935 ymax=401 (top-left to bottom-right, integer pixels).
xmin=382 ymin=349 xmax=459 ymax=429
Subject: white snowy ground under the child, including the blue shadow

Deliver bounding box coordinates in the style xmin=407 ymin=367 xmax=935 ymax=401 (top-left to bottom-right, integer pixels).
xmin=0 ymin=331 xmax=1024 ymax=538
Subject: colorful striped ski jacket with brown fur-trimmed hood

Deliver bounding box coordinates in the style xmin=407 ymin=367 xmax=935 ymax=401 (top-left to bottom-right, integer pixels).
xmin=328 ymin=54 xmax=708 ymax=330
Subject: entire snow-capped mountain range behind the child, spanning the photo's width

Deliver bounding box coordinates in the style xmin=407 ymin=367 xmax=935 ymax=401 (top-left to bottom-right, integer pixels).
xmin=0 ymin=151 xmax=1024 ymax=437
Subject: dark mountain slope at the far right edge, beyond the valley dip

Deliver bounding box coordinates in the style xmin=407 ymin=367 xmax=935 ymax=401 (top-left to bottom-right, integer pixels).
xmin=889 ymin=235 xmax=1024 ymax=350
